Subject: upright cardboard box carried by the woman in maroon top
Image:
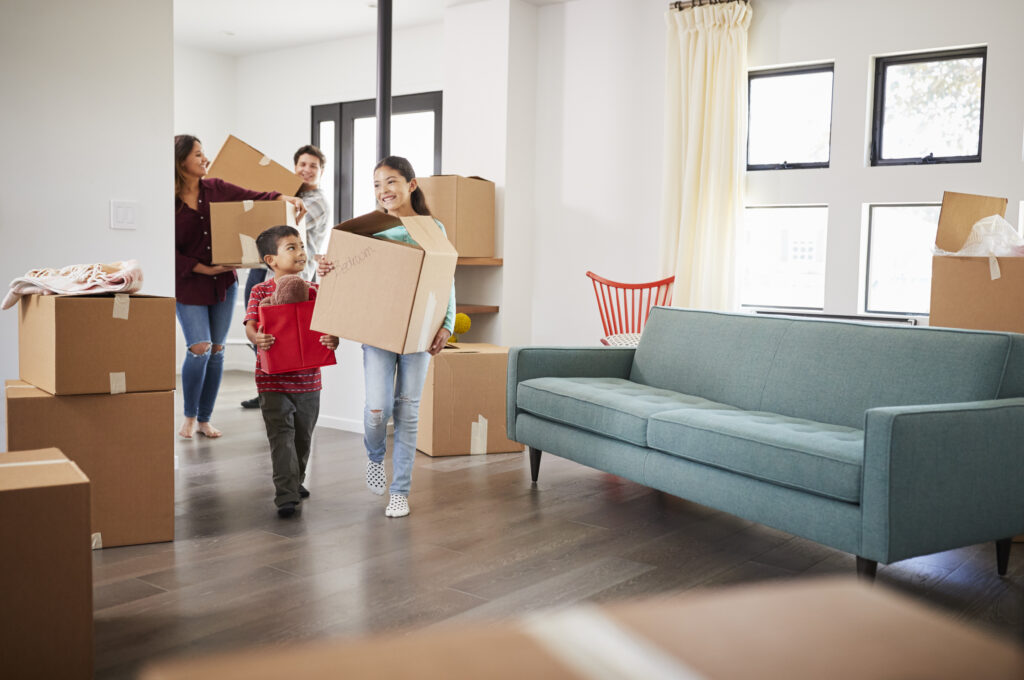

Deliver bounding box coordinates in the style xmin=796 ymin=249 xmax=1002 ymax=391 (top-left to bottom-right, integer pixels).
xmin=210 ymin=201 xmax=306 ymax=267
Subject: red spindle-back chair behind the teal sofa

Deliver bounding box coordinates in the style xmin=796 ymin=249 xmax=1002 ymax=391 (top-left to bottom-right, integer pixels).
xmin=587 ymin=271 xmax=676 ymax=345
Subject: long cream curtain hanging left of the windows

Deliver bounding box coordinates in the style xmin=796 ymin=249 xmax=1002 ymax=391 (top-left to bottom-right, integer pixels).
xmin=662 ymin=1 xmax=751 ymax=310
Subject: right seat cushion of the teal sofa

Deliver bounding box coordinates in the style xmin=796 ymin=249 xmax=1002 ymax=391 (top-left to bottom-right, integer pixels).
xmin=647 ymin=409 xmax=864 ymax=503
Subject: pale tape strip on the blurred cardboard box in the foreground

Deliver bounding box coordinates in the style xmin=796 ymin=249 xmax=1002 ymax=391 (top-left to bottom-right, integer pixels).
xmin=522 ymin=605 xmax=705 ymax=680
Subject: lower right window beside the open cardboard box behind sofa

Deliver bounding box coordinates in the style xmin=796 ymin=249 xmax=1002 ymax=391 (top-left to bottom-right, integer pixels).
xmin=864 ymin=205 xmax=940 ymax=314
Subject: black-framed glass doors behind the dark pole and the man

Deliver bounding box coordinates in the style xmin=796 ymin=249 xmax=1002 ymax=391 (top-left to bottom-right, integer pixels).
xmin=312 ymin=92 xmax=441 ymax=222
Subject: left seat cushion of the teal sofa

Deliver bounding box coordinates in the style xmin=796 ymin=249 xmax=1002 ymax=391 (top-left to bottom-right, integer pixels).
xmin=516 ymin=378 xmax=731 ymax=447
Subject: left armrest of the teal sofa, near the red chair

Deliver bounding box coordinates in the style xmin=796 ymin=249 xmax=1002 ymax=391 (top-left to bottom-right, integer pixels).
xmin=505 ymin=347 xmax=636 ymax=441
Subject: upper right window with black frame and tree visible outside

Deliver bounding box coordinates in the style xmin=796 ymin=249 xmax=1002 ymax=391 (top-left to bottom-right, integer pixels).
xmin=871 ymin=47 xmax=987 ymax=165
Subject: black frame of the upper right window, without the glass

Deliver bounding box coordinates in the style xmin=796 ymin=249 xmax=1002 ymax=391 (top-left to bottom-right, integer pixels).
xmin=870 ymin=45 xmax=988 ymax=167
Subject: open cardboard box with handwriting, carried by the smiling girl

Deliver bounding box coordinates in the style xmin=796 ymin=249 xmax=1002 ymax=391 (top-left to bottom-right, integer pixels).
xmin=311 ymin=212 xmax=458 ymax=354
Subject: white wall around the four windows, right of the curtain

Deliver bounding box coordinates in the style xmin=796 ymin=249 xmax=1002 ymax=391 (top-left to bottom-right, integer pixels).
xmin=748 ymin=0 xmax=1024 ymax=314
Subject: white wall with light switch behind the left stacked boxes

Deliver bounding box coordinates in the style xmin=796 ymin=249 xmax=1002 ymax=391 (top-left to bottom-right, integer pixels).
xmin=0 ymin=0 xmax=174 ymax=438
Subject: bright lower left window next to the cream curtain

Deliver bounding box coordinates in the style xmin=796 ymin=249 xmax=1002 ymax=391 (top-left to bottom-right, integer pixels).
xmin=739 ymin=206 xmax=828 ymax=309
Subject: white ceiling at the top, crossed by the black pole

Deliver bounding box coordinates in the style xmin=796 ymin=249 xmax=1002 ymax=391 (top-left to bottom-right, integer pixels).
xmin=174 ymin=0 xmax=568 ymax=56
